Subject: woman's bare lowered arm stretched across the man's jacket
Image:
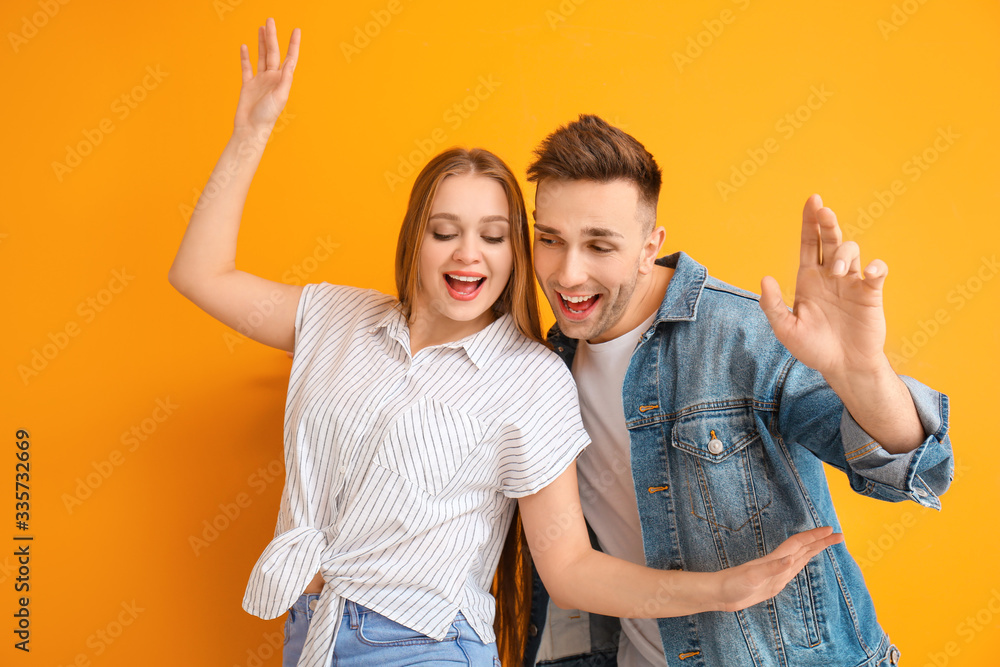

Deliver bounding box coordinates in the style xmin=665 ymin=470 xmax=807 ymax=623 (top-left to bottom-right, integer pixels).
xmin=518 ymin=463 xmax=843 ymax=618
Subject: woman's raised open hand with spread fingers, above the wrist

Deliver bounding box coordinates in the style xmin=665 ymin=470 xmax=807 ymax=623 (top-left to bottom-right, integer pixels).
xmin=233 ymin=18 xmax=300 ymax=133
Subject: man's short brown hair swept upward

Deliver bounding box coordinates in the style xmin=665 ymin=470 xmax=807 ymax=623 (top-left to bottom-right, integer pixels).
xmin=528 ymin=115 xmax=663 ymax=231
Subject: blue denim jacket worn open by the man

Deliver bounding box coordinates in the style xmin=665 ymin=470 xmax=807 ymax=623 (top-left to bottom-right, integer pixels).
xmin=526 ymin=253 xmax=954 ymax=667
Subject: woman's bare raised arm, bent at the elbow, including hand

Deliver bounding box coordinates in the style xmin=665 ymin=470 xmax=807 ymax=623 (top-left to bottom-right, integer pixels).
xmin=168 ymin=19 xmax=302 ymax=350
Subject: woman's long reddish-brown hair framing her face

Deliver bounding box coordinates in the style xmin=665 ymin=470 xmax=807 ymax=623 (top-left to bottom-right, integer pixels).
xmin=396 ymin=148 xmax=543 ymax=342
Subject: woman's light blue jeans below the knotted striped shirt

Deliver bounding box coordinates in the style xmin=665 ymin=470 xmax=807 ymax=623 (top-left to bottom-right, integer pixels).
xmin=281 ymin=595 xmax=500 ymax=667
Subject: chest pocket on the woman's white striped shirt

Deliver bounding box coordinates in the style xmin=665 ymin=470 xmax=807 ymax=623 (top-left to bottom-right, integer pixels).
xmin=375 ymin=398 xmax=486 ymax=495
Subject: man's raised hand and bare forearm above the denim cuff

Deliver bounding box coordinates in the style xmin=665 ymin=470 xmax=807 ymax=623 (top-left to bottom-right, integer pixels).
xmin=760 ymin=195 xmax=927 ymax=454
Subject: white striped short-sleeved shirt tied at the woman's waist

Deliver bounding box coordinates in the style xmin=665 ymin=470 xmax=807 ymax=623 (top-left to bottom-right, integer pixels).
xmin=243 ymin=283 xmax=589 ymax=667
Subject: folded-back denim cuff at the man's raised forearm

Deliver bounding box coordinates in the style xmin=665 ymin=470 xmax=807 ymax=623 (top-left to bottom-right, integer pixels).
xmin=840 ymin=376 xmax=955 ymax=509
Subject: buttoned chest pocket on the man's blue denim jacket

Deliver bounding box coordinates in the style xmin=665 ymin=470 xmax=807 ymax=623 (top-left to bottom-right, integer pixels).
xmin=671 ymin=407 xmax=771 ymax=531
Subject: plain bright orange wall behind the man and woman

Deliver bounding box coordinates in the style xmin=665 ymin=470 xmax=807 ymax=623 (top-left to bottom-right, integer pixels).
xmin=0 ymin=0 xmax=1000 ymax=667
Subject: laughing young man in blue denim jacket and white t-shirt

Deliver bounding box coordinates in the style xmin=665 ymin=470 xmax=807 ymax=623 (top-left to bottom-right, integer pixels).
xmin=525 ymin=116 xmax=953 ymax=667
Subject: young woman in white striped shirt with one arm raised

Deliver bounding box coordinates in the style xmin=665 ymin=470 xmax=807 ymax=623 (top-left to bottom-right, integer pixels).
xmin=170 ymin=19 xmax=841 ymax=667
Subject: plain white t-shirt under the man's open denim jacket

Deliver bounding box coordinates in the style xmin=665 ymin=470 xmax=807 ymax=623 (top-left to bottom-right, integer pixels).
xmin=573 ymin=313 xmax=667 ymax=667
